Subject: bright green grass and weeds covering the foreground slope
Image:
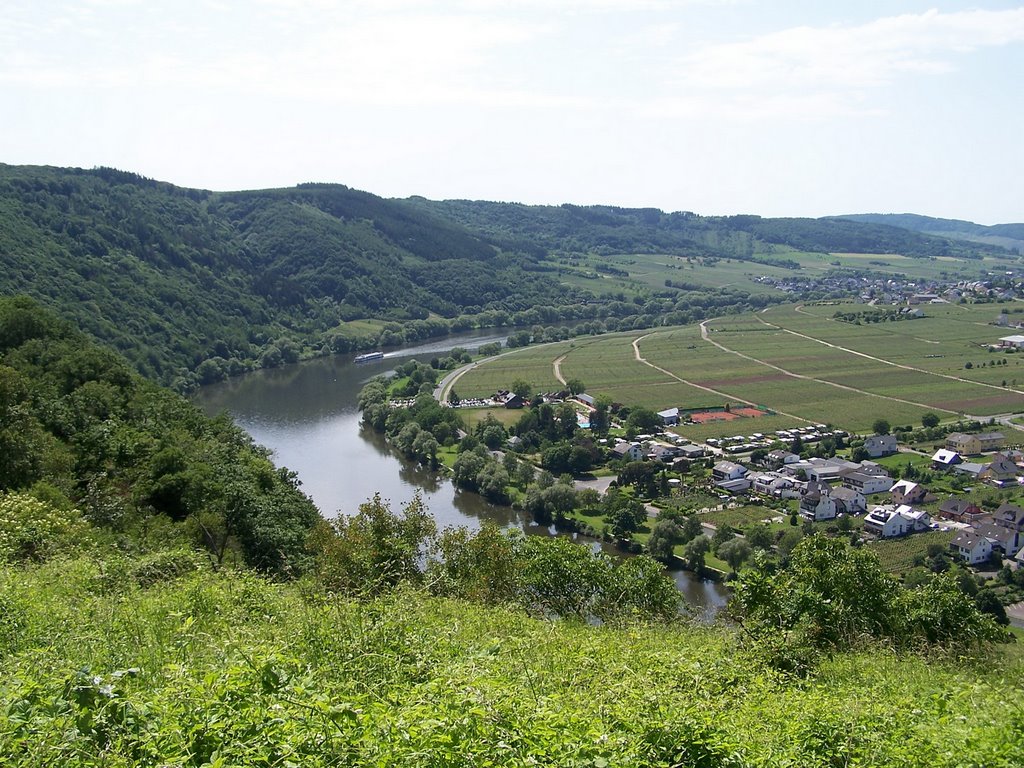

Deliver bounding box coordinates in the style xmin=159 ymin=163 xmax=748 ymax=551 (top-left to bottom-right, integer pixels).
xmin=0 ymin=560 xmax=1024 ymax=768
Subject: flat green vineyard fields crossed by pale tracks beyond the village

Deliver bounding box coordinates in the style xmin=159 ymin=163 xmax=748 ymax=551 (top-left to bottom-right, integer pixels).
xmin=457 ymin=304 xmax=1024 ymax=439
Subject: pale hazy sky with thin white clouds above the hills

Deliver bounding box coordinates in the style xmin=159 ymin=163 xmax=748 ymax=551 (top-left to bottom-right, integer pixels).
xmin=0 ymin=0 xmax=1024 ymax=224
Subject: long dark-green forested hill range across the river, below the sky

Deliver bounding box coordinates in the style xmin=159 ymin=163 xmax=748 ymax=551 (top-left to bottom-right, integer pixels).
xmin=0 ymin=165 xmax=1006 ymax=389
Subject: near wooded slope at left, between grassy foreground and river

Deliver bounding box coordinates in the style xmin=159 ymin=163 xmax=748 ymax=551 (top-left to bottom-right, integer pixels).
xmin=0 ymin=298 xmax=319 ymax=573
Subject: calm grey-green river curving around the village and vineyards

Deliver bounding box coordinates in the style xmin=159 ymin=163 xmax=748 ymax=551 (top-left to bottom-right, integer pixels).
xmin=195 ymin=331 xmax=727 ymax=617
